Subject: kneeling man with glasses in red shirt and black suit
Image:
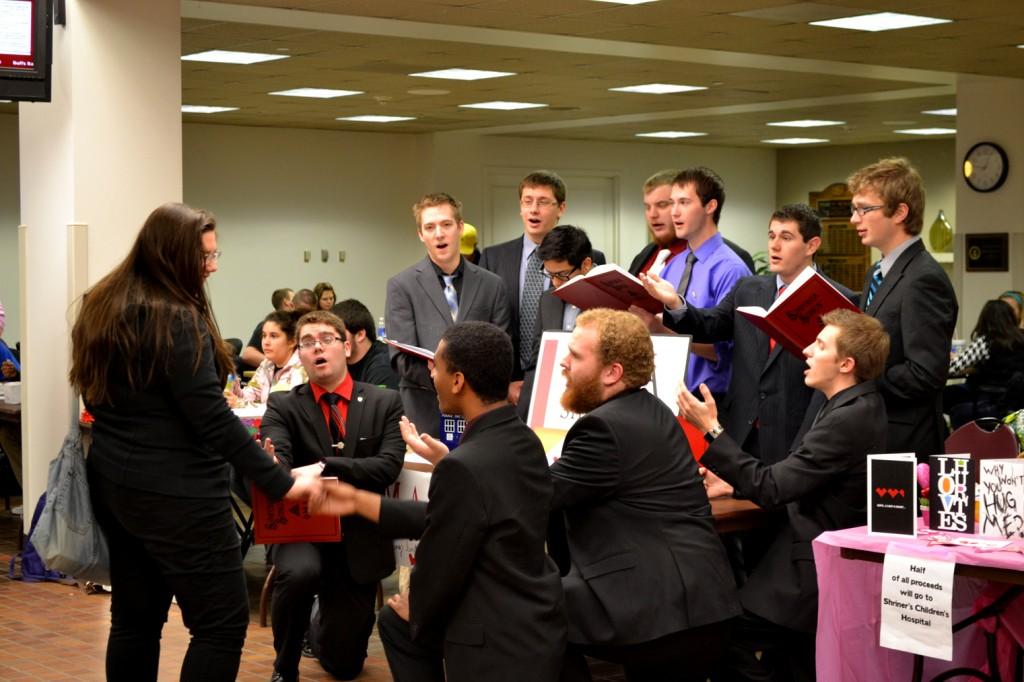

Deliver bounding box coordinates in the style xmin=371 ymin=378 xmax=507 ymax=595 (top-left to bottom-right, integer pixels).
xmin=261 ymin=310 xmax=406 ymax=682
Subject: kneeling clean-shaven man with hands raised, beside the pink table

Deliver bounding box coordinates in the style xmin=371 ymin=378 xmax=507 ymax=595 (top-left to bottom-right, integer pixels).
xmin=679 ymin=309 xmax=889 ymax=680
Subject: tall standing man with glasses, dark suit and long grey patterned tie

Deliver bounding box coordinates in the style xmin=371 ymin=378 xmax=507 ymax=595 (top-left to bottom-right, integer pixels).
xmin=477 ymin=170 xmax=604 ymax=404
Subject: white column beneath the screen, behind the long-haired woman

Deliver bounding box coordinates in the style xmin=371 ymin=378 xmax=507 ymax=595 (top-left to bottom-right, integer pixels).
xmin=18 ymin=0 xmax=182 ymax=527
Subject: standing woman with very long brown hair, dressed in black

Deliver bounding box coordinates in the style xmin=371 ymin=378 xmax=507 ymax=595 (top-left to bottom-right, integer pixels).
xmin=70 ymin=204 xmax=313 ymax=682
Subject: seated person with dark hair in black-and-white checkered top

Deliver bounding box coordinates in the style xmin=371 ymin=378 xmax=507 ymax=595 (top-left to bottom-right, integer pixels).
xmin=942 ymin=300 xmax=1024 ymax=429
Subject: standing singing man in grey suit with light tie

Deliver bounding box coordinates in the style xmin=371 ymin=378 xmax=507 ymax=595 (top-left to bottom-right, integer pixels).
xmin=384 ymin=193 xmax=509 ymax=438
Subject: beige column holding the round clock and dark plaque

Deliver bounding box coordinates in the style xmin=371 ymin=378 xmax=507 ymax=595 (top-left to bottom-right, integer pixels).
xmin=950 ymin=76 xmax=1024 ymax=338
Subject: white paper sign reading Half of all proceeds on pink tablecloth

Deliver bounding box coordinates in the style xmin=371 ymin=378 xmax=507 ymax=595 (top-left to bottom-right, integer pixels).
xmin=879 ymin=552 xmax=956 ymax=660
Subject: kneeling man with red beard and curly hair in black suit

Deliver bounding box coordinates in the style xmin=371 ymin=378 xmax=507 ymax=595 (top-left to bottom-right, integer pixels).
xmin=551 ymin=308 xmax=740 ymax=681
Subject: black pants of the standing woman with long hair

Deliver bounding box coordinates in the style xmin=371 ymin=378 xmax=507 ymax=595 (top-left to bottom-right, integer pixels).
xmin=89 ymin=470 xmax=249 ymax=682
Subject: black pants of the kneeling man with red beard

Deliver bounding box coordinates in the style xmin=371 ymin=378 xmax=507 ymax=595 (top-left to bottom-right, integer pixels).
xmin=561 ymin=621 xmax=732 ymax=682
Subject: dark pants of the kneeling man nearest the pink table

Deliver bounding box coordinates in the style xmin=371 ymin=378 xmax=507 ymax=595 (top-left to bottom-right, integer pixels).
xmin=711 ymin=611 xmax=815 ymax=682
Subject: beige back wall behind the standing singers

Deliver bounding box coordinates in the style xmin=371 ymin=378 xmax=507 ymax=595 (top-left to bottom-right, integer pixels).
xmin=0 ymin=116 xmax=970 ymax=340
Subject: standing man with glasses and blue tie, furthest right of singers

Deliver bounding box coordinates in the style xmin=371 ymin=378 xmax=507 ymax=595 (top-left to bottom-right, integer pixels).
xmin=847 ymin=159 xmax=957 ymax=459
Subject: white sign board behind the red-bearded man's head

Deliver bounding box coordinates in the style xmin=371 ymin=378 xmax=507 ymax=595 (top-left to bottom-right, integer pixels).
xmin=526 ymin=332 xmax=690 ymax=431
